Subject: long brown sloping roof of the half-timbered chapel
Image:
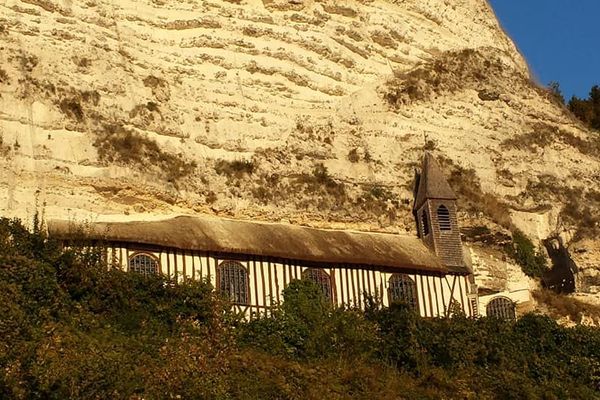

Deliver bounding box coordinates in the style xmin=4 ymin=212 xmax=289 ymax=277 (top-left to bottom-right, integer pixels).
xmin=48 ymin=216 xmax=464 ymax=273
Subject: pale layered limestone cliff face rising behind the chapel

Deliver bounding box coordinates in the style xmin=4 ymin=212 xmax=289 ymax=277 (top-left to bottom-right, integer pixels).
xmin=0 ymin=0 xmax=600 ymax=296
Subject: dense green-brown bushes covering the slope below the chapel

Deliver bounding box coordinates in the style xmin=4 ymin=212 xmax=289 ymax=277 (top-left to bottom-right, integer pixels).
xmin=0 ymin=219 xmax=600 ymax=399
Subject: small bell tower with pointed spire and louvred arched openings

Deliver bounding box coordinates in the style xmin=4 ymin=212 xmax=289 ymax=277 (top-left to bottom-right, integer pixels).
xmin=414 ymin=153 xmax=465 ymax=267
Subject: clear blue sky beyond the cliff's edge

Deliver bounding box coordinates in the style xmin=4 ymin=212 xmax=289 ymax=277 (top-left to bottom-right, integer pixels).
xmin=490 ymin=0 xmax=600 ymax=100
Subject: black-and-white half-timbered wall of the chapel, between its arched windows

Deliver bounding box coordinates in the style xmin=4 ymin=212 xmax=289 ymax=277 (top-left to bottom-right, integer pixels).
xmin=108 ymin=244 xmax=474 ymax=317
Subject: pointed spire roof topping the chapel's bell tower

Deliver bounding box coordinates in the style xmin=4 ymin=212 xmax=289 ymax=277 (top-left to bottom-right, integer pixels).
xmin=414 ymin=152 xmax=457 ymax=210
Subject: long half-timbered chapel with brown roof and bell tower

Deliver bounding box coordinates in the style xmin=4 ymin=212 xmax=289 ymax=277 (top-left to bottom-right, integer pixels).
xmin=48 ymin=153 xmax=514 ymax=318
